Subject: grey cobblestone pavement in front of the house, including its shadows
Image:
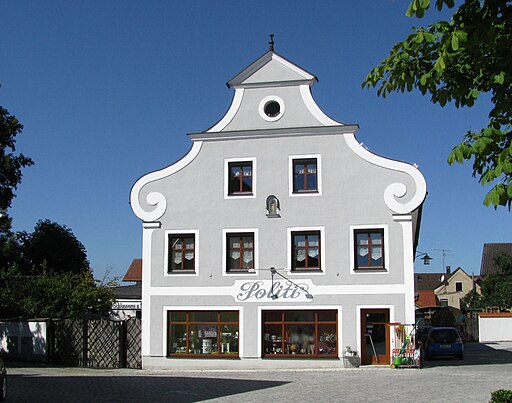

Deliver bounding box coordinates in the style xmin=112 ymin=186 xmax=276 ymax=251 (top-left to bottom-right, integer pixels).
xmin=7 ymin=343 xmax=512 ymax=403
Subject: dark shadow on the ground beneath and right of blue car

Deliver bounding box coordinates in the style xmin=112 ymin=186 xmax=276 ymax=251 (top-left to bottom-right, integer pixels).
xmin=424 ymin=343 xmax=512 ymax=368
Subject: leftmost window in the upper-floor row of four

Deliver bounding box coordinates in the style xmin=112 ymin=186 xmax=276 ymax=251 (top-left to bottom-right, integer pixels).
xmin=167 ymin=234 xmax=196 ymax=273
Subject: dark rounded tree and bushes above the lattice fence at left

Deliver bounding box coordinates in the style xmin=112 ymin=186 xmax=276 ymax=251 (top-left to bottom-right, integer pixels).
xmin=0 ymin=220 xmax=116 ymax=319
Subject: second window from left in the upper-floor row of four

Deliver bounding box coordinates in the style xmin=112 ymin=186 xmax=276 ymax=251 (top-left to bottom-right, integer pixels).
xmin=226 ymin=232 xmax=254 ymax=272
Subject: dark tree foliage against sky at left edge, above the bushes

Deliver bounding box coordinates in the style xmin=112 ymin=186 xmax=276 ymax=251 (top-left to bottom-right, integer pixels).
xmin=0 ymin=106 xmax=33 ymax=233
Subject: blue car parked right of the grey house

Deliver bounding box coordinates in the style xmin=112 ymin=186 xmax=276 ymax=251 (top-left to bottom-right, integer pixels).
xmin=424 ymin=327 xmax=464 ymax=360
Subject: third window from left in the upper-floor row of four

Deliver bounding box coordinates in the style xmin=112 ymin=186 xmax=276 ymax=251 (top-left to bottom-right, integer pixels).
xmin=291 ymin=231 xmax=321 ymax=271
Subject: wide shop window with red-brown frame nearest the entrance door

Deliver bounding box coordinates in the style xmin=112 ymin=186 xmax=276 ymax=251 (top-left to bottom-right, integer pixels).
xmin=263 ymin=310 xmax=338 ymax=358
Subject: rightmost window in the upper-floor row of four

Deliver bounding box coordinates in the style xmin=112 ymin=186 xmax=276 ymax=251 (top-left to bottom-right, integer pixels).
xmin=354 ymin=229 xmax=385 ymax=269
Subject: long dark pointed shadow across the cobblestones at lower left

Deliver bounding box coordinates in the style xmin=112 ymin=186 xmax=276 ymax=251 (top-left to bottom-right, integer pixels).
xmin=7 ymin=374 xmax=288 ymax=402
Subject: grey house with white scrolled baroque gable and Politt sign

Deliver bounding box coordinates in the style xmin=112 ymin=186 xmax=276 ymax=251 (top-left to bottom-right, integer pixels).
xmin=131 ymin=43 xmax=426 ymax=368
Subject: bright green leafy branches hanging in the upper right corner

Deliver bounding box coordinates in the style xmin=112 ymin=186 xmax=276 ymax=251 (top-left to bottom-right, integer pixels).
xmin=363 ymin=0 xmax=512 ymax=209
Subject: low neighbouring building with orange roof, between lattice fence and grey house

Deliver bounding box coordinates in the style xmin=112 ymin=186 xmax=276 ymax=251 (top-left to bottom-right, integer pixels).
xmin=110 ymin=259 xmax=142 ymax=320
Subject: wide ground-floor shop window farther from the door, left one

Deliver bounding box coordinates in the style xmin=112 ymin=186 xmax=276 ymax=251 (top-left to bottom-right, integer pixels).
xmin=167 ymin=311 xmax=239 ymax=357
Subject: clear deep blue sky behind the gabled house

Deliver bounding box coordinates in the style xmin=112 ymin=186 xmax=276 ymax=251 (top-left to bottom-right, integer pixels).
xmin=0 ymin=0 xmax=512 ymax=279
